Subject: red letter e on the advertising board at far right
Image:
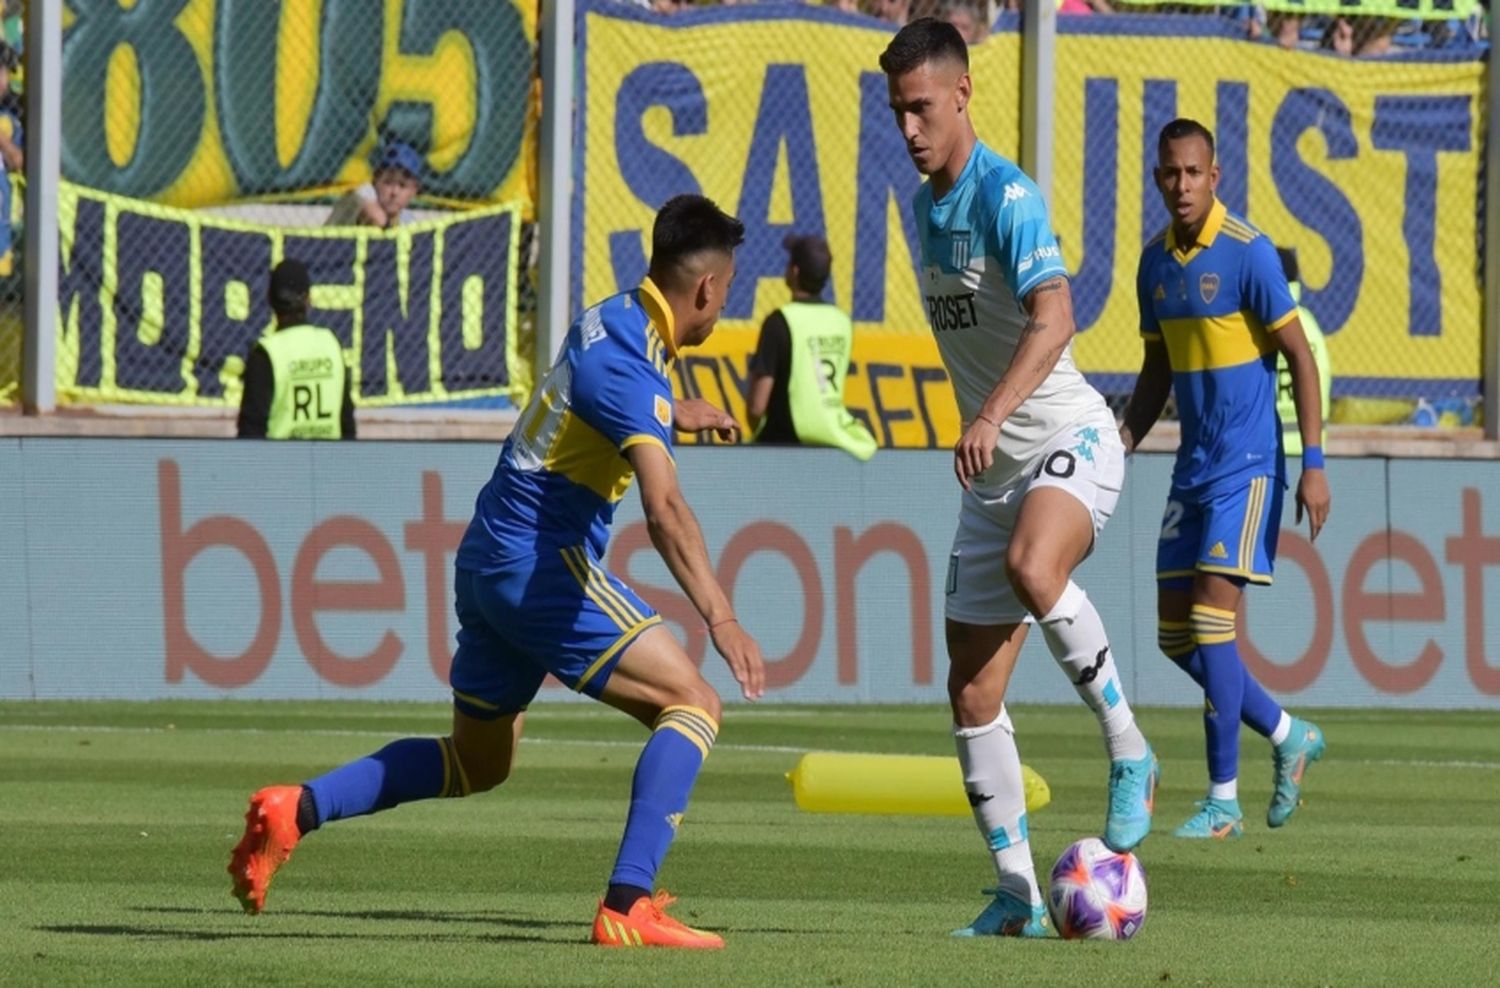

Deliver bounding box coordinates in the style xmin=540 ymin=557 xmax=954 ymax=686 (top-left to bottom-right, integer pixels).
xmin=1344 ymin=528 xmax=1445 ymax=693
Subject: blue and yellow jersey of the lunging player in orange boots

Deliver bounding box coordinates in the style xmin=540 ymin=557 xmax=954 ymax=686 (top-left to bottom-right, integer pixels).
xmin=458 ymin=279 xmax=677 ymax=573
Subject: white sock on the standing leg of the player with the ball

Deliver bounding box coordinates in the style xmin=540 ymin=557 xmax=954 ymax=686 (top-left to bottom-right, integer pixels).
xmin=953 ymin=706 xmax=1041 ymax=906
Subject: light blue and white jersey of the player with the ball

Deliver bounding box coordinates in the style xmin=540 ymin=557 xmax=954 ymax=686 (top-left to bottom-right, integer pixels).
xmin=912 ymin=144 xmax=1106 ymax=487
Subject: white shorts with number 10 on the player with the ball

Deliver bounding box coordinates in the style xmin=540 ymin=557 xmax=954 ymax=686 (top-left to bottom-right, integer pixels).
xmin=944 ymin=411 xmax=1125 ymax=625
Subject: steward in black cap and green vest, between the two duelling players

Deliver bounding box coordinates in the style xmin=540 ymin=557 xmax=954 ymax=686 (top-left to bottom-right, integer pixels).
xmin=746 ymin=235 xmax=876 ymax=460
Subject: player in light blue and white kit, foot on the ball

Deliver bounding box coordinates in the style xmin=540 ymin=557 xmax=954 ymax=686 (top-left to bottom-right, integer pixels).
xmin=881 ymin=18 xmax=1158 ymax=937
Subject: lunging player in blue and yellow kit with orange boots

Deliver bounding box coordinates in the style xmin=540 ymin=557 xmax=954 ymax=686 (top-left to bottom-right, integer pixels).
xmin=230 ymin=195 xmax=765 ymax=948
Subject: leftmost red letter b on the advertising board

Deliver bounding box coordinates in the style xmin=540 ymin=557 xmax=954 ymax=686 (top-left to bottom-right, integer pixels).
xmin=156 ymin=460 xmax=281 ymax=688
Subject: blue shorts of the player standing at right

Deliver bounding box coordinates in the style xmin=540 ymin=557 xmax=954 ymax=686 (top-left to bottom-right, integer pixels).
xmin=1157 ymin=477 xmax=1283 ymax=585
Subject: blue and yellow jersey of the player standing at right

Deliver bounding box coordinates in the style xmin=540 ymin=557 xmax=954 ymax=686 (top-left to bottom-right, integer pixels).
xmin=1136 ymin=201 xmax=1298 ymax=493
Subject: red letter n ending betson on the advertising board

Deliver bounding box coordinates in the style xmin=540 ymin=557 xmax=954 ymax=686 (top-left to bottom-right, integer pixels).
xmin=834 ymin=522 xmax=933 ymax=685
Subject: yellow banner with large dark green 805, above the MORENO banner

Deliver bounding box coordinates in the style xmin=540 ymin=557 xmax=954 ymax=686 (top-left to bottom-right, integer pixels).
xmin=63 ymin=0 xmax=537 ymax=219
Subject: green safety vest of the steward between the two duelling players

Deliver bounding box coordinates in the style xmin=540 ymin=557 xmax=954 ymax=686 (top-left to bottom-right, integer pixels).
xmin=762 ymin=301 xmax=876 ymax=460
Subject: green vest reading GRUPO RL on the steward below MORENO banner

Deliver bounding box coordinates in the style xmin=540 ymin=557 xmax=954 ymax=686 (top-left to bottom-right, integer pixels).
xmin=261 ymin=325 xmax=344 ymax=439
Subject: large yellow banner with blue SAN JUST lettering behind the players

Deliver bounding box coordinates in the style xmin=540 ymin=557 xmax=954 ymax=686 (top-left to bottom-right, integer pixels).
xmin=572 ymin=0 xmax=1482 ymax=447
